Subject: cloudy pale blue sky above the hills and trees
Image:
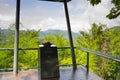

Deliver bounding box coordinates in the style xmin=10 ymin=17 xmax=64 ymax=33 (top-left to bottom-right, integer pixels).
xmin=0 ymin=0 xmax=120 ymax=32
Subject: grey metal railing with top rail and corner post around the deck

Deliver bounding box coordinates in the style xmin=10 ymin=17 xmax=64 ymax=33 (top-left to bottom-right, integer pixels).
xmin=0 ymin=47 xmax=120 ymax=79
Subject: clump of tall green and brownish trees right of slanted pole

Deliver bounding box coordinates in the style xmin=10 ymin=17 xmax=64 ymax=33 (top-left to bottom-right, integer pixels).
xmin=77 ymin=23 xmax=120 ymax=80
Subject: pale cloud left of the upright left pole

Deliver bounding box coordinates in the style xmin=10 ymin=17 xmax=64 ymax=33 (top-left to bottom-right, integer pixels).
xmin=0 ymin=1 xmax=15 ymax=28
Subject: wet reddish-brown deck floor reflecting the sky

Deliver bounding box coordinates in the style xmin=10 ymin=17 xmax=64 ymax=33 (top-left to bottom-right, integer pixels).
xmin=0 ymin=67 xmax=103 ymax=80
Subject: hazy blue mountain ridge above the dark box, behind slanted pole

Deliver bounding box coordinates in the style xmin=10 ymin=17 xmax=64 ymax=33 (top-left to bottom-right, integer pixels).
xmin=39 ymin=29 xmax=80 ymax=39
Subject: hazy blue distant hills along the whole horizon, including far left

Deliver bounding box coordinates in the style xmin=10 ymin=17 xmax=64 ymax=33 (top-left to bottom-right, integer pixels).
xmin=0 ymin=29 xmax=80 ymax=39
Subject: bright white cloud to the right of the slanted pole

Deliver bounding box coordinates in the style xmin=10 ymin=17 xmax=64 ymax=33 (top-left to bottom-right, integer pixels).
xmin=70 ymin=0 xmax=120 ymax=31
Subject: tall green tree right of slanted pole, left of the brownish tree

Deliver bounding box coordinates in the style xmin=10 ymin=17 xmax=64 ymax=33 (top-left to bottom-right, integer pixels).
xmin=77 ymin=23 xmax=105 ymax=71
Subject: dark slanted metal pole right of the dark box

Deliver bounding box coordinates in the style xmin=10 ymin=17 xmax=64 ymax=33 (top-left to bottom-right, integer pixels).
xmin=64 ymin=0 xmax=77 ymax=70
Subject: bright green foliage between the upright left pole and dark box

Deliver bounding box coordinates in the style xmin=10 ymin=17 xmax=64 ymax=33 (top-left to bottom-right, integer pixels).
xmin=19 ymin=30 xmax=41 ymax=67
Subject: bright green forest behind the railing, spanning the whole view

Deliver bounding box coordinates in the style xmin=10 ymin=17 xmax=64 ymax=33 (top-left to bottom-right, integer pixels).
xmin=0 ymin=23 xmax=120 ymax=80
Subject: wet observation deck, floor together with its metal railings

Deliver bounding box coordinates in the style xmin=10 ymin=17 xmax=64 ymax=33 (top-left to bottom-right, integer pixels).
xmin=0 ymin=47 xmax=120 ymax=80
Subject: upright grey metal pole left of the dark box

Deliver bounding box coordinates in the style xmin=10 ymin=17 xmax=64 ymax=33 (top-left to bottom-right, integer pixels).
xmin=13 ymin=0 xmax=20 ymax=75
